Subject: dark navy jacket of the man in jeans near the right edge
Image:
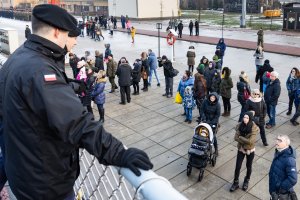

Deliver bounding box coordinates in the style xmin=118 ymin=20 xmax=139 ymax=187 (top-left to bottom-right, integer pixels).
xmin=264 ymin=78 xmax=281 ymax=106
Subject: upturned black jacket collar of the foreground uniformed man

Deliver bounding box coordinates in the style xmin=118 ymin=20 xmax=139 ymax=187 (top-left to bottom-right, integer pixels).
xmin=24 ymin=34 xmax=66 ymax=61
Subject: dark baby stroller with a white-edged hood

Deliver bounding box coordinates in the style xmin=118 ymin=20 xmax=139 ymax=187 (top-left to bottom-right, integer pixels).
xmin=187 ymin=123 xmax=217 ymax=181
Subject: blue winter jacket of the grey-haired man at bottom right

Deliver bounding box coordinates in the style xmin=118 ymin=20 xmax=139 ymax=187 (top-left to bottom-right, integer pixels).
xmin=269 ymin=146 xmax=297 ymax=194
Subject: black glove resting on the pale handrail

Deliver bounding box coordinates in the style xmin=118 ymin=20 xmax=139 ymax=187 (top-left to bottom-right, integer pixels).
xmin=121 ymin=148 xmax=153 ymax=176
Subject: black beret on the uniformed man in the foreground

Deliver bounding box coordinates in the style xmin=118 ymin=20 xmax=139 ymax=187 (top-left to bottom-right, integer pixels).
xmin=32 ymin=4 xmax=77 ymax=31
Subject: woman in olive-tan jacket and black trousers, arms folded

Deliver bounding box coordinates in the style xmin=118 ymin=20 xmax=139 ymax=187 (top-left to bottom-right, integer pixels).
xmin=230 ymin=112 xmax=259 ymax=192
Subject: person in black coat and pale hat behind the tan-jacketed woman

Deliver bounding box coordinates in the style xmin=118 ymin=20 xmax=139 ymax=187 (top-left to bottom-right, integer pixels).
xmin=245 ymin=89 xmax=269 ymax=146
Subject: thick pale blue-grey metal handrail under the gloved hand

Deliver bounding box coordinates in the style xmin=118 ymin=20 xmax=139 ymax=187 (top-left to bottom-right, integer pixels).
xmin=119 ymin=168 xmax=187 ymax=200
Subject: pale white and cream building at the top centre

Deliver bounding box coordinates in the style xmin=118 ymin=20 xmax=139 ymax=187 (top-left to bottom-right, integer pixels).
xmin=108 ymin=0 xmax=179 ymax=19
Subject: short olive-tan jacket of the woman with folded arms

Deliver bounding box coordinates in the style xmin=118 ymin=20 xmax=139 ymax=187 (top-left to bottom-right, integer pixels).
xmin=234 ymin=122 xmax=259 ymax=150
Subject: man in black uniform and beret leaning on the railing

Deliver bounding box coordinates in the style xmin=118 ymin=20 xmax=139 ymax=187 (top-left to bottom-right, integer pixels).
xmin=0 ymin=4 xmax=153 ymax=200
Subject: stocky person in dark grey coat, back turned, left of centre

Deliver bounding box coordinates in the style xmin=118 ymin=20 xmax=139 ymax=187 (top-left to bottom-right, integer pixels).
xmin=116 ymin=57 xmax=132 ymax=105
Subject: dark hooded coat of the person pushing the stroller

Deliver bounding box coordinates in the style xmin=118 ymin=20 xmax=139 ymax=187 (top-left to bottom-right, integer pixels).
xmin=201 ymin=92 xmax=221 ymax=125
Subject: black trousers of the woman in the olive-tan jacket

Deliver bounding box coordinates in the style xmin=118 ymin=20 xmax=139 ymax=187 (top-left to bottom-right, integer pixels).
xmin=234 ymin=150 xmax=255 ymax=181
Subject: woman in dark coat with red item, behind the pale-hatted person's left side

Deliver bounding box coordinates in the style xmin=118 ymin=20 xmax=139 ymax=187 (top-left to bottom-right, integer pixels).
xmin=236 ymin=71 xmax=251 ymax=122
